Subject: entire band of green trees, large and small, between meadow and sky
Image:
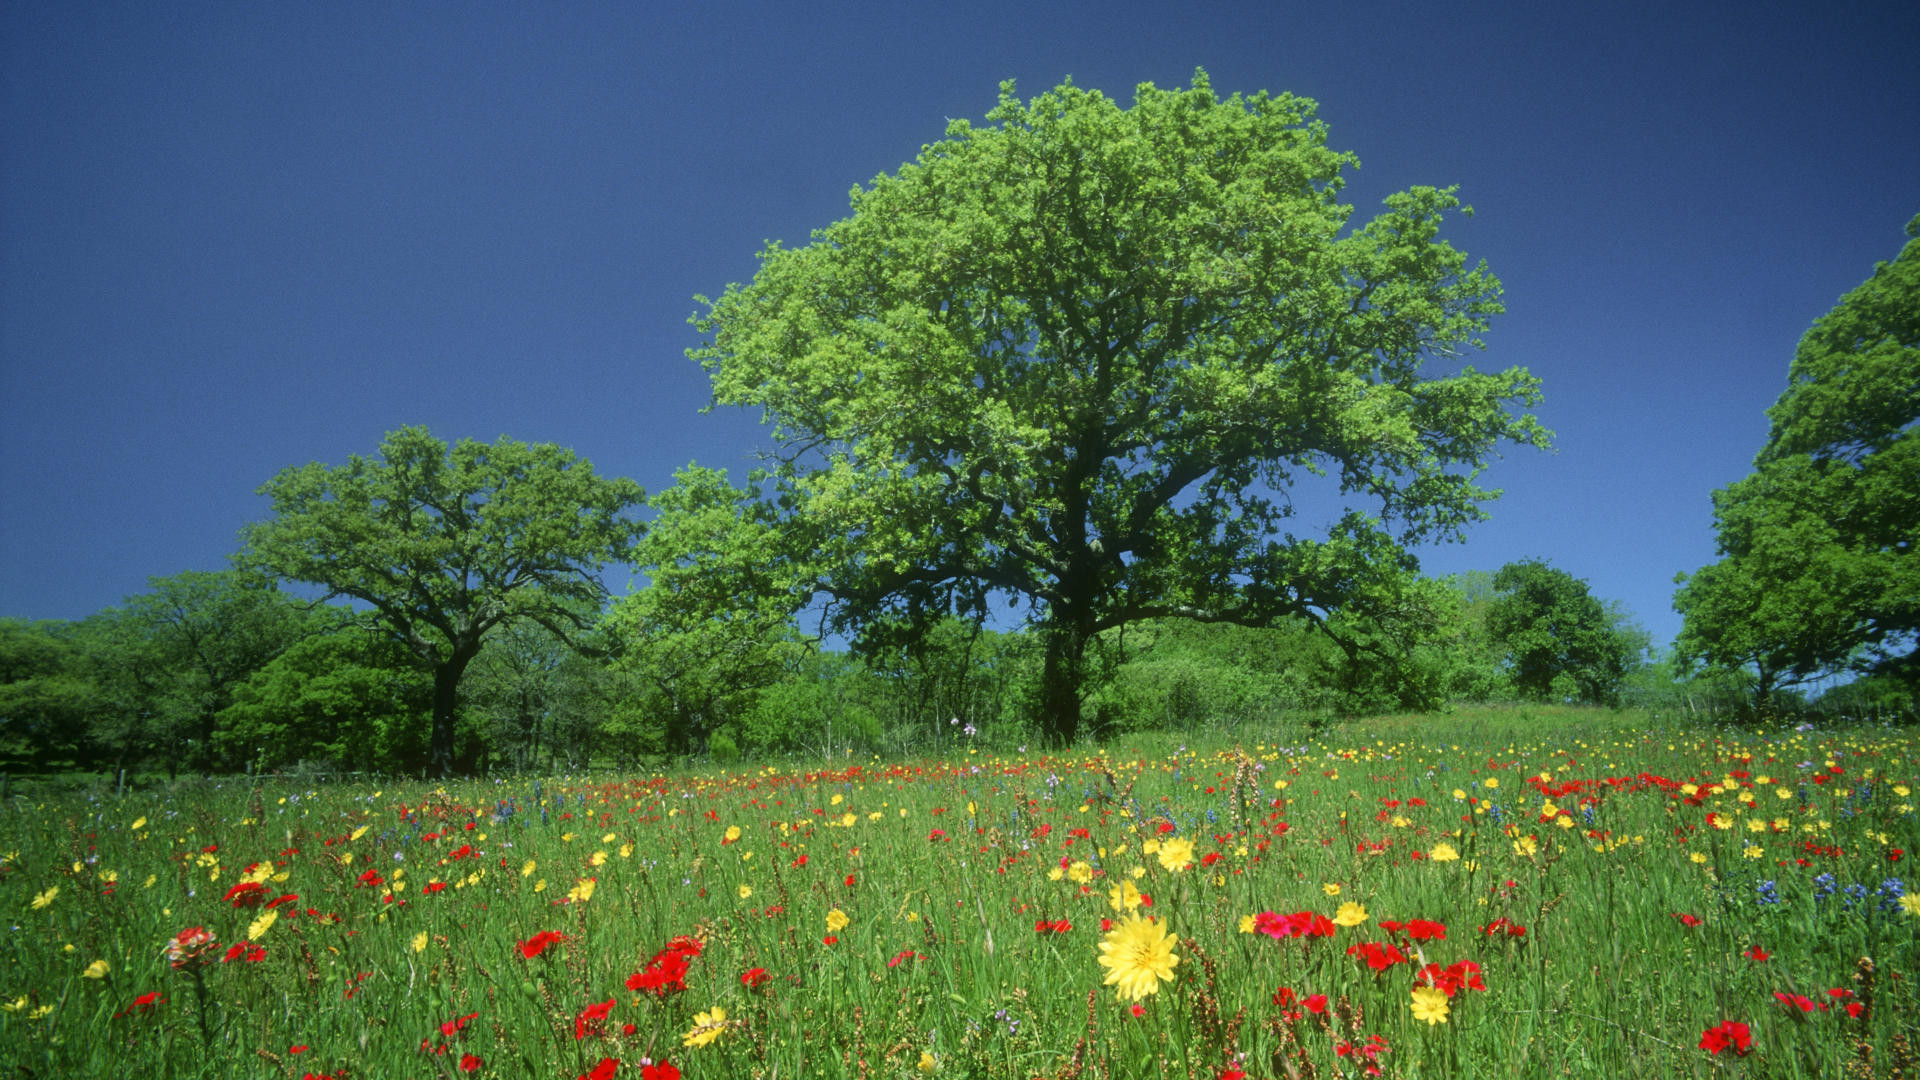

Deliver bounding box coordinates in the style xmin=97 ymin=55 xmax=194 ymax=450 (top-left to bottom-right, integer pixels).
xmin=0 ymin=73 xmax=1920 ymax=774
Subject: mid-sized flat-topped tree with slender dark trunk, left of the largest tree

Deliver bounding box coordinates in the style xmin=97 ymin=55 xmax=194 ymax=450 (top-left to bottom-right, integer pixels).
xmin=240 ymin=427 xmax=645 ymax=776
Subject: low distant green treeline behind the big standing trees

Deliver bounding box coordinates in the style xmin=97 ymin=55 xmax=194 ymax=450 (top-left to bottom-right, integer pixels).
xmin=0 ymin=563 xmax=1866 ymax=773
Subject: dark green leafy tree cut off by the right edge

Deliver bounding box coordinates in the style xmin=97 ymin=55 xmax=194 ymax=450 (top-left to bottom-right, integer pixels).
xmin=1674 ymin=217 xmax=1920 ymax=707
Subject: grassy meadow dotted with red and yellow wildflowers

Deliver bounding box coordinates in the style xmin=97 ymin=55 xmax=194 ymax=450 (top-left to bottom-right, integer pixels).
xmin=0 ymin=711 xmax=1920 ymax=1080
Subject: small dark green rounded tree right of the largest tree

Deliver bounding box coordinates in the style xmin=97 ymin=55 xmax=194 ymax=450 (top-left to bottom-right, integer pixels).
xmin=1486 ymin=559 xmax=1647 ymax=705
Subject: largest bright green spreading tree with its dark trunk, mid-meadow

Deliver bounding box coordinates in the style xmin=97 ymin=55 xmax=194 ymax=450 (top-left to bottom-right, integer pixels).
xmin=689 ymin=73 xmax=1548 ymax=740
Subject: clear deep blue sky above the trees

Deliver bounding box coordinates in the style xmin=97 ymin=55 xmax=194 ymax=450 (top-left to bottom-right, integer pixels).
xmin=0 ymin=0 xmax=1920 ymax=642
